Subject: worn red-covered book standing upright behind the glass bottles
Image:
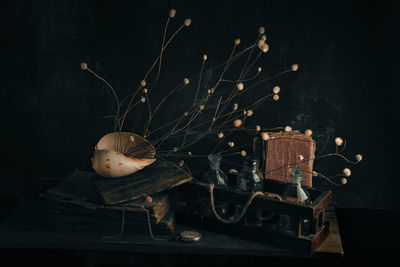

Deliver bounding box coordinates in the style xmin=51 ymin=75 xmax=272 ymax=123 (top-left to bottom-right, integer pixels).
xmin=253 ymin=131 xmax=316 ymax=187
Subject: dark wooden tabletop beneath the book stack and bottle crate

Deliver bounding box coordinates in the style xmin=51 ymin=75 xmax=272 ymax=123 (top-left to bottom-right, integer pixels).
xmin=0 ymin=198 xmax=343 ymax=264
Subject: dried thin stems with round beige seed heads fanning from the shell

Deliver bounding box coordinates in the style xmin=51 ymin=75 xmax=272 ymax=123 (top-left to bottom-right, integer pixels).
xmin=81 ymin=9 xmax=362 ymax=188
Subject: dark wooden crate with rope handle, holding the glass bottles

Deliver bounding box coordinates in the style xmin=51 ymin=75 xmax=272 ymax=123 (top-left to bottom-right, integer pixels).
xmin=177 ymin=179 xmax=332 ymax=253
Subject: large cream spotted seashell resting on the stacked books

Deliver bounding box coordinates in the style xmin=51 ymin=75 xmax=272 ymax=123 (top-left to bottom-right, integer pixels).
xmin=91 ymin=132 xmax=156 ymax=178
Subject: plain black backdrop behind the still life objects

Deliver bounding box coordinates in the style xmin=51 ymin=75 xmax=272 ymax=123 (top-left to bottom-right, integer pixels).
xmin=0 ymin=0 xmax=399 ymax=208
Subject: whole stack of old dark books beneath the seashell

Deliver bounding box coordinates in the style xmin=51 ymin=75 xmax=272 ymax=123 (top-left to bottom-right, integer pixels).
xmin=41 ymin=162 xmax=191 ymax=238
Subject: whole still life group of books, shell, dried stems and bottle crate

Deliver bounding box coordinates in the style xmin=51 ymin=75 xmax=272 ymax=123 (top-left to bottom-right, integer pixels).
xmin=43 ymin=9 xmax=362 ymax=252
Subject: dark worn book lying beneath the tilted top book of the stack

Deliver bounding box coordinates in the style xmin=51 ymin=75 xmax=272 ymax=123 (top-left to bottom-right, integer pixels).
xmin=40 ymin=170 xmax=173 ymax=224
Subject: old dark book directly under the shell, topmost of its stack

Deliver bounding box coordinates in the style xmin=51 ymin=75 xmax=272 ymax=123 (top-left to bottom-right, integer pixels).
xmin=93 ymin=160 xmax=192 ymax=204
